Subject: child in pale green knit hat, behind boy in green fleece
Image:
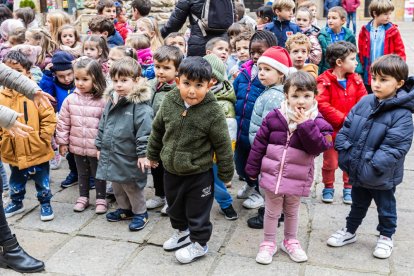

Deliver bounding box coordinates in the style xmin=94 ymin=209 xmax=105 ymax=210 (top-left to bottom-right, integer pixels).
xmin=204 ymin=54 xmax=239 ymax=220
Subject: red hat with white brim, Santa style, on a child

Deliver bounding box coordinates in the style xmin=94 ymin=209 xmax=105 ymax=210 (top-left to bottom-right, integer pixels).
xmin=257 ymin=46 xmax=296 ymax=77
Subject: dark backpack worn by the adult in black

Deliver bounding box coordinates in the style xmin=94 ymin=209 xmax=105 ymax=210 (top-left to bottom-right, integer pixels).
xmin=191 ymin=0 xmax=234 ymax=36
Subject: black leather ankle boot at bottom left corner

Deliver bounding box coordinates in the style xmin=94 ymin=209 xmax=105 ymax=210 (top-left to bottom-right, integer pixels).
xmin=0 ymin=235 xmax=45 ymax=273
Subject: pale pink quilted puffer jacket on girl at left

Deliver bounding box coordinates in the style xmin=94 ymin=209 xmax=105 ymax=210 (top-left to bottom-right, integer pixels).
xmin=56 ymin=90 xmax=106 ymax=157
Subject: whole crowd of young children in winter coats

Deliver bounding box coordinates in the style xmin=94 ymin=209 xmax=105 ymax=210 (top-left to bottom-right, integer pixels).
xmin=0 ymin=0 xmax=414 ymax=264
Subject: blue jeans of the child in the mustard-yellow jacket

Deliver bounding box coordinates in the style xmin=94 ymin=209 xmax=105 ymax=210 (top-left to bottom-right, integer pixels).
xmin=10 ymin=162 xmax=52 ymax=204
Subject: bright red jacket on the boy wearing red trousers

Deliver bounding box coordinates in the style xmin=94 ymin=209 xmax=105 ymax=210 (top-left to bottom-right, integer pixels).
xmin=316 ymin=69 xmax=367 ymax=137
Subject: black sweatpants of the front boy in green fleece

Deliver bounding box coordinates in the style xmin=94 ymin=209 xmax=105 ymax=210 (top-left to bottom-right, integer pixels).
xmin=164 ymin=169 xmax=214 ymax=246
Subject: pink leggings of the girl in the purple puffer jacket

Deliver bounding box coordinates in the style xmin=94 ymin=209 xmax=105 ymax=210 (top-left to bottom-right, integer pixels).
xmin=264 ymin=191 xmax=300 ymax=242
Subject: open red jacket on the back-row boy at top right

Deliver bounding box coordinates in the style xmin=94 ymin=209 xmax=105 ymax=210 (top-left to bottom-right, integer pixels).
xmin=358 ymin=21 xmax=406 ymax=85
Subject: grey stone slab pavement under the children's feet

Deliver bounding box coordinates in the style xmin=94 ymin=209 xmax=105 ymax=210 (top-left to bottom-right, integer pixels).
xmin=0 ymin=23 xmax=414 ymax=276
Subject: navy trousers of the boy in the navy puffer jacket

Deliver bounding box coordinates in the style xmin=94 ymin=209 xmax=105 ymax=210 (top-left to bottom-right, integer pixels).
xmin=346 ymin=187 xmax=397 ymax=238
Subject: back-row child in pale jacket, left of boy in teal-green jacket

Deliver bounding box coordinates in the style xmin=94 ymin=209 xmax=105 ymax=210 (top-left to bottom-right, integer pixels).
xmin=296 ymin=8 xmax=322 ymax=65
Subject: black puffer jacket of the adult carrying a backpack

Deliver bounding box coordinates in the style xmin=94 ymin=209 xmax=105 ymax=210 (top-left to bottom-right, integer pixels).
xmin=161 ymin=0 xmax=227 ymax=56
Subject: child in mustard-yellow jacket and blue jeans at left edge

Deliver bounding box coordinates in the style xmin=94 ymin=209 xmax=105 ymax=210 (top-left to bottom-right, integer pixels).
xmin=0 ymin=51 xmax=56 ymax=221
